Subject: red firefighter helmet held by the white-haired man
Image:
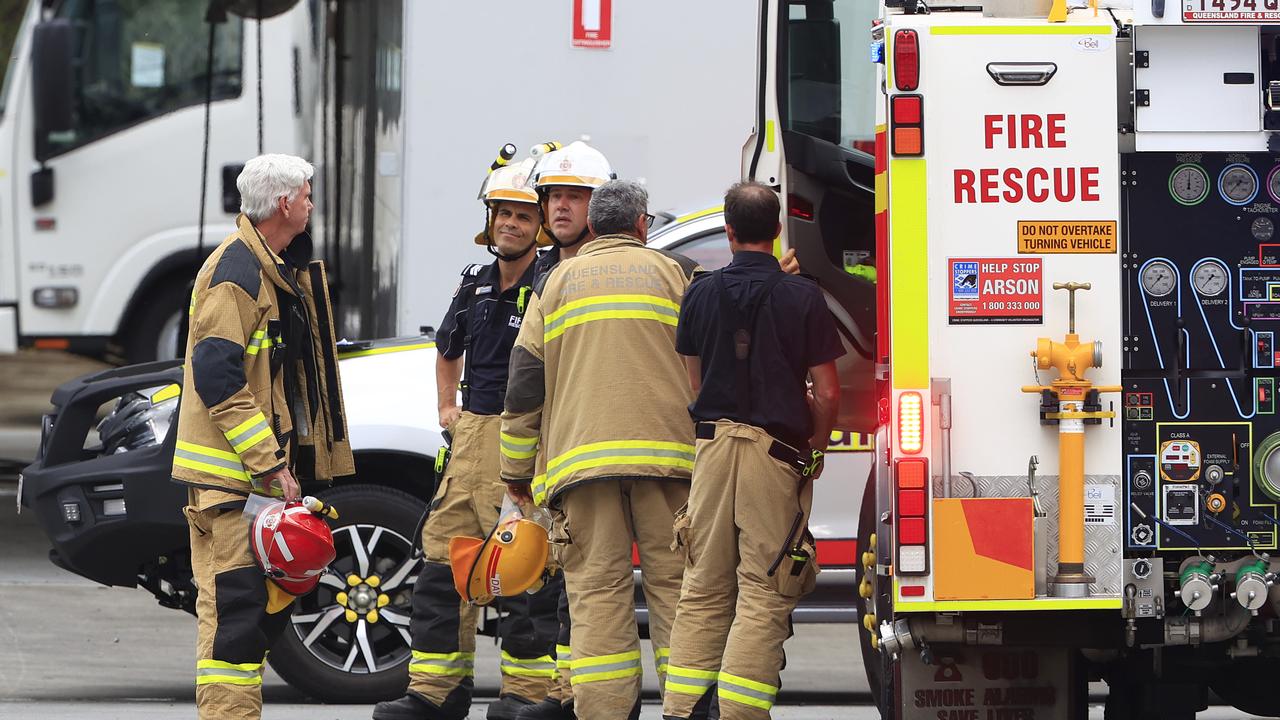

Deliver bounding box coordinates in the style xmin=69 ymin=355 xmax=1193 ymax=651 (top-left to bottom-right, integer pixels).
xmin=248 ymin=501 xmax=337 ymax=594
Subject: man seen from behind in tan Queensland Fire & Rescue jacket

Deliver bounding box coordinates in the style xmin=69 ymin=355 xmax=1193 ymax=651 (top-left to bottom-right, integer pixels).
xmin=502 ymin=181 xmax=696 ymax=720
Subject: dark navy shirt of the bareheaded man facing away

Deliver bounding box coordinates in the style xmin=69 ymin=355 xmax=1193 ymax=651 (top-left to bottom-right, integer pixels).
xmin=676 ymin=251 xmax=845 ymax=450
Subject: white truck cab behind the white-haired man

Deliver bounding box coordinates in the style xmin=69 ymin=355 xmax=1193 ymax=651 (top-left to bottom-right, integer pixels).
xmin=0 ymin=0 xmax=312 ymax=361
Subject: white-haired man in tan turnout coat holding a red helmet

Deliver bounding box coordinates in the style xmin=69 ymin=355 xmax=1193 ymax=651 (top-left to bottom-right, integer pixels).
xmin=173 ymin=155 xmax=355 ymax=719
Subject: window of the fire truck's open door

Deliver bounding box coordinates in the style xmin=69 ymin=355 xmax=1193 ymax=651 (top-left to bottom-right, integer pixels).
xmin=778 ymin=0 xmax=879 ymax=154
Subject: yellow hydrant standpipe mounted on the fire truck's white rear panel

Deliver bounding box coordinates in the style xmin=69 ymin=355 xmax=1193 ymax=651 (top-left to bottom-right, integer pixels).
xmin=1023 ymin=282 xmax=1120 ymax=597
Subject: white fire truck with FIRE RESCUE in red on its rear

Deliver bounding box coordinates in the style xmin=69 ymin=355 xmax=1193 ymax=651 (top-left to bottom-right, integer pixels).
xmin=744 ymin=0 xmax=1280 ymax=720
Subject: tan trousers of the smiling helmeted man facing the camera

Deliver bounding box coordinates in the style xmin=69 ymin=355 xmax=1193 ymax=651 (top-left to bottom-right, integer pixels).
xmin=408 ymin=411 xmax=558 ymax=706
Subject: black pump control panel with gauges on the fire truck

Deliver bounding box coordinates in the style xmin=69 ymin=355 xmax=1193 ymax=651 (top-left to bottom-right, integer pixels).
xmin=1121 ymin=152 xmax=1280 ymax=551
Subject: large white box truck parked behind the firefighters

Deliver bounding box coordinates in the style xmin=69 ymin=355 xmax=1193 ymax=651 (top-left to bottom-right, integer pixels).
xmin=0 ymin=0 xmax=754 ymax=361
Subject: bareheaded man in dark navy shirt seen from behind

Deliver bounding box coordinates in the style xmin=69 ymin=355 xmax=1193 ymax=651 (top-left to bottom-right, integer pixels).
xmin=663 ymin=182 xmax=844 ymax=720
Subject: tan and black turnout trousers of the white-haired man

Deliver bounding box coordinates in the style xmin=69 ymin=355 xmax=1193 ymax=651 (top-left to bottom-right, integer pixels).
xmin=183 ymin=488 xmax=292 ymax=720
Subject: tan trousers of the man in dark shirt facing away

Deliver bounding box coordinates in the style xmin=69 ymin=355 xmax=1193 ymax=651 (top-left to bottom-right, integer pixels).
xmin=665 ymin=420 xmax=817 ymax=720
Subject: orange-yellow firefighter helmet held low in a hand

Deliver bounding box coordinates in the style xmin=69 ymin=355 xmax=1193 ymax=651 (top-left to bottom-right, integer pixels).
xmin=449 ymin=515 xmax=548 ymax=605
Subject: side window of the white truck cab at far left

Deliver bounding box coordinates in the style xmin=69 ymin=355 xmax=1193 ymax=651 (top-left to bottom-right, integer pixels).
xmin=50 ymin=0 xmax=243 ymax=152
